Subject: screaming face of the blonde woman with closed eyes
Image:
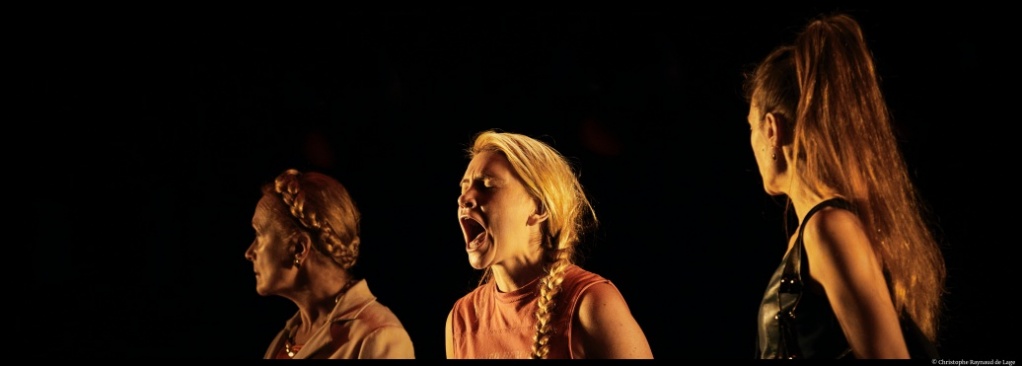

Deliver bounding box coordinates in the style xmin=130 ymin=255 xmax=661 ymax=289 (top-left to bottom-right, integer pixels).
xmin=458 ymin=151 xmax=539 ymax=269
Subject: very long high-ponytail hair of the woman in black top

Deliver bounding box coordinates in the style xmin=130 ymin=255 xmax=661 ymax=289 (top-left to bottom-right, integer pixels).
xmin=745 ymin=14 xmax=945 ymax=341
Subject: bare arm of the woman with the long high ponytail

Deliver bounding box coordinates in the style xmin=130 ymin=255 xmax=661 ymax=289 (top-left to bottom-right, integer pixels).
xmin=803 ymin=210 xmax=909 ymax=359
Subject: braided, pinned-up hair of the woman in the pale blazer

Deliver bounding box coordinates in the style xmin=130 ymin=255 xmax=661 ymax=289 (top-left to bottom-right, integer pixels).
xmin=263 ymin=169 xmax=361 ymax=270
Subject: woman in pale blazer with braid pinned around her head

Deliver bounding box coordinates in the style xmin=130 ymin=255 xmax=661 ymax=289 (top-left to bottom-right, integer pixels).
xmin=245 ymin=170 xmax=415 ymax=359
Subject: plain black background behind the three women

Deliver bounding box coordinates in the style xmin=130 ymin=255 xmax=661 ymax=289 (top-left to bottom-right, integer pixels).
xmin=27 ymin=4 xmax=1019 ymax=360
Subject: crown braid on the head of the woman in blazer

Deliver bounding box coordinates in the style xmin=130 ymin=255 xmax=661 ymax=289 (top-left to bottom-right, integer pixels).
xmin=274 ymin=169 xmax=360 ymax=270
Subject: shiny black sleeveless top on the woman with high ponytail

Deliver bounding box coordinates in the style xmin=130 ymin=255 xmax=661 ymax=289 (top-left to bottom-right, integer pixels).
xmin=756 ymin=198 xmax=938 ymax=360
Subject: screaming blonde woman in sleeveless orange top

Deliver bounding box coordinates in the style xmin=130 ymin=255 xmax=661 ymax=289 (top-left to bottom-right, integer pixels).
xmin=447 ymin=131 xmax=653 ymax=359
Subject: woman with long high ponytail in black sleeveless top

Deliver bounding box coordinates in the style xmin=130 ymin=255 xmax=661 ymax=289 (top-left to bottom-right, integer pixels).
xmin=745 ymin=13 xmax=945 ymax=358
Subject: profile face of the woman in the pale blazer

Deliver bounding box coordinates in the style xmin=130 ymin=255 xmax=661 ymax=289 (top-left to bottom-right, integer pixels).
xmin=245 ymin=195 xmax=295 ymax=296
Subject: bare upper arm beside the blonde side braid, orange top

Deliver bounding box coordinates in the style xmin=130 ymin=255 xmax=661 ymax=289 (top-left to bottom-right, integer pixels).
xmin=574 ymin=283 xmax=653 ymax=359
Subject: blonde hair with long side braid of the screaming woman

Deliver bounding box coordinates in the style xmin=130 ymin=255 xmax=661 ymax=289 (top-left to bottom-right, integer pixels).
xmin=468 ymin=130 xmax=597 ymax=359
